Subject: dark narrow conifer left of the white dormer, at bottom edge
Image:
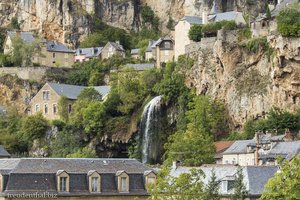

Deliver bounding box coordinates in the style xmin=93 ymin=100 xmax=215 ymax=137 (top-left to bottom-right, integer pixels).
xmin=204 ymin=170 xmax=220 ymax=200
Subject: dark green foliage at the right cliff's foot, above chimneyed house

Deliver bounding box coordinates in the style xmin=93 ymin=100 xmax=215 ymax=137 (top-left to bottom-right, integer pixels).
xmin=244 ymin=108 xmax=300 ymax=139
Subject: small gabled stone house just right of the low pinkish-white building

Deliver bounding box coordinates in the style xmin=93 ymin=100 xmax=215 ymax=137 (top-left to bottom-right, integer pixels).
xmin=101 ymin=42 xmax=125 ymax=60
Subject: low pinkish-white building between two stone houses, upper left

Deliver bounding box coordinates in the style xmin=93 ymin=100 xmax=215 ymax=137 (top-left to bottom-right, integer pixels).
xmin=74 ymin=47 xmax=103 ymax=62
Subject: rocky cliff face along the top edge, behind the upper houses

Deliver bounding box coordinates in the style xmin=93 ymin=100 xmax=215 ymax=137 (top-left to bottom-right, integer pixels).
xmin=0 ymin=0 xmax=265 ymax=46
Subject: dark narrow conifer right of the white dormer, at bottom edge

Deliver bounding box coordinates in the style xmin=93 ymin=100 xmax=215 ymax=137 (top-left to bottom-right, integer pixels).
xmin=232 ymin=167 xmax=248 ymax=200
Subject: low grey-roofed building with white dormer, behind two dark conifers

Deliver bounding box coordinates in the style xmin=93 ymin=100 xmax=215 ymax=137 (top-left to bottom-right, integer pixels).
xmin=170 ymin=165 xmax=278 ymax=200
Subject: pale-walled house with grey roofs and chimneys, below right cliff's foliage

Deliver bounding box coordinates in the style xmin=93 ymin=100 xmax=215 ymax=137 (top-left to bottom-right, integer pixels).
xmin=222 ymin=134 xmax=300 ymax=166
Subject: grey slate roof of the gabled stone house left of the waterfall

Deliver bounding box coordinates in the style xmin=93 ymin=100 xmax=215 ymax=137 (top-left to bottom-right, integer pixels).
xmin=48 ymin=83 xmax=110 ymax=100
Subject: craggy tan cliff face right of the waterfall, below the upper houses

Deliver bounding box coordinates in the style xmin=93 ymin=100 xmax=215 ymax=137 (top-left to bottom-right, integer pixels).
xmin=187 ymin=33 xmax=300 ymax=128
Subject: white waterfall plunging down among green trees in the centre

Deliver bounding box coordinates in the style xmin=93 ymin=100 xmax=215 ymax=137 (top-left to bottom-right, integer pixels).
xmin=140 ymin=96 xmax=161 ymax=163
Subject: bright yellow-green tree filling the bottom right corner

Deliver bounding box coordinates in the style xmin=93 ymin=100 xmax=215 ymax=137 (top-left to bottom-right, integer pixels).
xmin=260 ymin=155 xmax=300 ymax=200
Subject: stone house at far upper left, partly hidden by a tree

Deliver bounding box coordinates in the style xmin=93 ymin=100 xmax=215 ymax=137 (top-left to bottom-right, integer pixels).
xmin=3 ymin=31 xmax=35 ymax=54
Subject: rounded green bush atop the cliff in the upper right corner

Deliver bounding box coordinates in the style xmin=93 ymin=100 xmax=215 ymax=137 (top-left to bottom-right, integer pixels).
xmin=276 ymin=3 xmax=300 ymax=37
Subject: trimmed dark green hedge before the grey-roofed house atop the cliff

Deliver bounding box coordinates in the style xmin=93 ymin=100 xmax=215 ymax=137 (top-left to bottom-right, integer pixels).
xmin=202 ymin=20 xmax=236 ymax=35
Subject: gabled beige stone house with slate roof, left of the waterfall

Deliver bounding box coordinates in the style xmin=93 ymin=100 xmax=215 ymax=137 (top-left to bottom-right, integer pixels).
xmin=29 ymin=83 xmax=110 ymax=120
